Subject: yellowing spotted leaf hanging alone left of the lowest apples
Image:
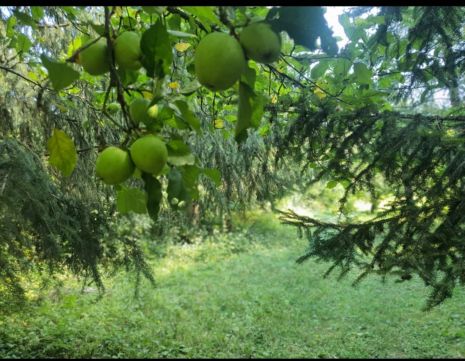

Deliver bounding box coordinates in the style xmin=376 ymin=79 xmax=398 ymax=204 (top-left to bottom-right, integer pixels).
xmin=47 ymin=128 xmax=77 ymax=177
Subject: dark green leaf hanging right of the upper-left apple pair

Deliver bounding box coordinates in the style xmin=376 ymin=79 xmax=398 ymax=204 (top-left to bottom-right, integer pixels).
xmin=140 ymin=19 xmax=173 ymax=78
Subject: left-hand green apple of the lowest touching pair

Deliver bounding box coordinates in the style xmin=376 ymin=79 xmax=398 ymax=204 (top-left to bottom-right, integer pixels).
xmin=95 ymin=146 xmax=134 ymax=184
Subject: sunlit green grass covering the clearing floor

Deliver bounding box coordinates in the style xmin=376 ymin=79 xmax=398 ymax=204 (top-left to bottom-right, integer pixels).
xmin=0 ymin=212 xmax=465 ymax=358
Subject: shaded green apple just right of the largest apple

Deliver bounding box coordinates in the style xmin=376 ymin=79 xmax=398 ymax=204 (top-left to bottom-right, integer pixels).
xmin=239 ymin=22 xmax=281 ymax=64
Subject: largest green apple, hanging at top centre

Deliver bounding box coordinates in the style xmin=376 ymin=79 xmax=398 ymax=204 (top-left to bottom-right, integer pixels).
xmin=194 ymin=32 xmax=246 ymax=91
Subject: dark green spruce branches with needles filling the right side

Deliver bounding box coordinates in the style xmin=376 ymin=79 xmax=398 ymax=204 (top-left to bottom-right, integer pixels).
xmin=281 ymin=7 xmax=465 ymax=309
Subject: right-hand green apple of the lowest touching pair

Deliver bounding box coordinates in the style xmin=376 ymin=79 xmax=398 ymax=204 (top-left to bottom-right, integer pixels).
xmin=129 ymin=134 xmax=168 ymax=175
